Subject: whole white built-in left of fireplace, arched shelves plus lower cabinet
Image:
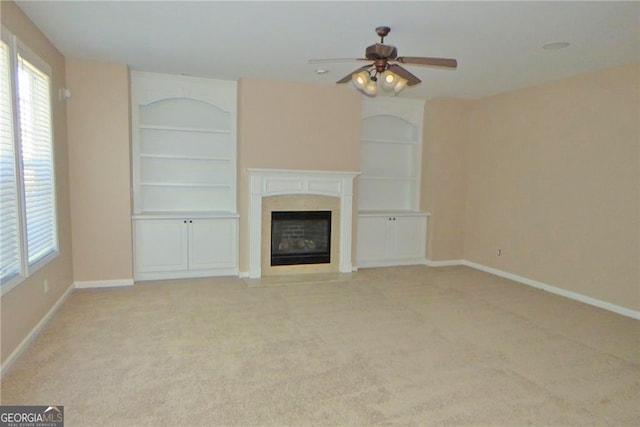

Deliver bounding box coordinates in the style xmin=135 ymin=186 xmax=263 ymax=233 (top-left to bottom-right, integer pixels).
xmin=131 ymin=72 xmax=238 ymax=279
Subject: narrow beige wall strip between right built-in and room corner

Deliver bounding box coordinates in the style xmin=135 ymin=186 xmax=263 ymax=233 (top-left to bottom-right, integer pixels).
xmin=420 ymin=99 xmax=470 ymax=261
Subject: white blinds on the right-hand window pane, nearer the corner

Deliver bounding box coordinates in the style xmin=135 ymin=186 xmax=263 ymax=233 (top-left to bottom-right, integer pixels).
xmin=18 ymin=54 xmax=57 ymax=267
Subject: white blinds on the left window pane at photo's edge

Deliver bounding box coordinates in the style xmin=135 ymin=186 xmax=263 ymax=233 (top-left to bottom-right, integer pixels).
xmin=0 ymin=41 xmax=20 ymax=284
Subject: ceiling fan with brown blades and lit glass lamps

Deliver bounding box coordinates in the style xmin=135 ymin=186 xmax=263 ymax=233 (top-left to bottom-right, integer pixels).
xmin=309 ymin=27 xmax=458 ymax=96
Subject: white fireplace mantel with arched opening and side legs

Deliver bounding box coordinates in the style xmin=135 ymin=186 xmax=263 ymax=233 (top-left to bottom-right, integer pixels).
xmin=249 ymin=169 xmax=360 ymax=278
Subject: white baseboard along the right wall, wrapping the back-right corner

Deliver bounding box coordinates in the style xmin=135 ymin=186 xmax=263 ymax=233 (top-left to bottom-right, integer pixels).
xmin=425 ymin=259 xmax=640 ymax=320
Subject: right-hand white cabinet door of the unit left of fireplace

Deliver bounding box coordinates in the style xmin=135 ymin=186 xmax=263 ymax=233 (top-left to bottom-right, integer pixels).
xmin=189 ymin=219 xmax=237 ymax=270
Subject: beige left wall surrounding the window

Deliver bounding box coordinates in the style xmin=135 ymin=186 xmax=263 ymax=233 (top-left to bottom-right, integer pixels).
xmin=0 ymin=1 xmax=73 ymax=362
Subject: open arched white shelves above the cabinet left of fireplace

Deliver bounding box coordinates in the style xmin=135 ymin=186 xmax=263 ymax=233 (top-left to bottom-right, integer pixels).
xmin=132 ymin=77 xmax=236 ymax=213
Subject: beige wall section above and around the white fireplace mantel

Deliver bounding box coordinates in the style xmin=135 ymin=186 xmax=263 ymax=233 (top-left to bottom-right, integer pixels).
xmin=238 ymin=80 xmax=361 ymax=272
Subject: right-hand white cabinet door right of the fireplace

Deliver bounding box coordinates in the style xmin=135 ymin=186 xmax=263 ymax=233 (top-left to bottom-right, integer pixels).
xmin=392 ymin=216 xmax=427 ymax=260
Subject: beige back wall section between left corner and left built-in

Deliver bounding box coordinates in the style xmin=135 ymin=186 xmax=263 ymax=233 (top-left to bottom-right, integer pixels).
xmin=67 ymin=60 xmax=133 ymax=282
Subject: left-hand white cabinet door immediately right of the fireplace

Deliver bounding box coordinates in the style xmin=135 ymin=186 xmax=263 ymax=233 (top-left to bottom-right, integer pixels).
xmin=358 ymin=216 xmax=391 ymax=265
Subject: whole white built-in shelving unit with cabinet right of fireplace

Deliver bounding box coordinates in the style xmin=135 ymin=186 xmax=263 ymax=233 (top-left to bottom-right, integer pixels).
xmin=358 ymin=97 xmax=428 ymax=267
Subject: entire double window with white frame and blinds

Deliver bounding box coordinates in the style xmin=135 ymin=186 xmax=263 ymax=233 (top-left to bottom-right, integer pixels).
xmin=0 ymin=29 xmax=58 ymax=294
